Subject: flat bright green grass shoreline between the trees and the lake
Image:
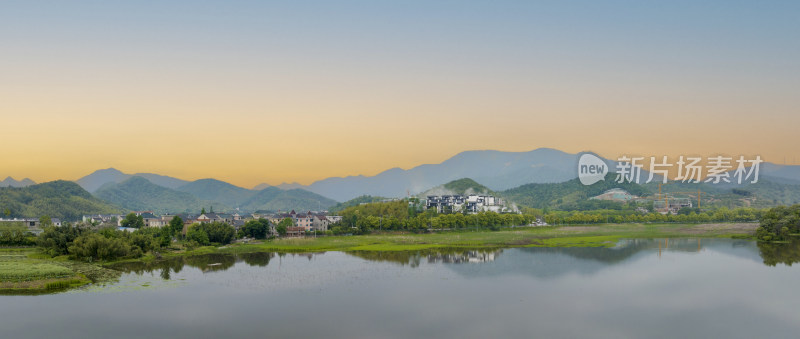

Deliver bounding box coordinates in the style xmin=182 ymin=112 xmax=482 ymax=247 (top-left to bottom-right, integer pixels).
xmin=0 ymin=223 xmax=759 ymax=295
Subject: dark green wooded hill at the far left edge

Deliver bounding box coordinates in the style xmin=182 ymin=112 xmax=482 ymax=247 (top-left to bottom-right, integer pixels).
xmin=0 ymin=180 xmax=122 ymax=221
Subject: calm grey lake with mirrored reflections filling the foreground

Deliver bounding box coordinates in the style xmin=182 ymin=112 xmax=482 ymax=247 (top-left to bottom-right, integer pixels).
xmin=0 ymin=239 xmax=800 ymax=338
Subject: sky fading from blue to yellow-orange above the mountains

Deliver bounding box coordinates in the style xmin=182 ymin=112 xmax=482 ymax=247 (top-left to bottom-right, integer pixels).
xmin=0 ymin=0 xmax=800 ymax=187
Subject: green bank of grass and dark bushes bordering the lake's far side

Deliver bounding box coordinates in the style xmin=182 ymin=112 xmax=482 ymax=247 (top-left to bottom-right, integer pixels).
xmin=0 ymin=220 xmax=758 ymax=293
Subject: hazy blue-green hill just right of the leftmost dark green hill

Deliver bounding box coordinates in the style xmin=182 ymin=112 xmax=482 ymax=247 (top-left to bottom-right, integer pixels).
xmin=94 ymin=176 xmax=224 ymax=213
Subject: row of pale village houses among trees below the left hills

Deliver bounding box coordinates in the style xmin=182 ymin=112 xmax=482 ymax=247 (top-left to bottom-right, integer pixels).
xmin=83 ymin=210 xmax=342 ymax=236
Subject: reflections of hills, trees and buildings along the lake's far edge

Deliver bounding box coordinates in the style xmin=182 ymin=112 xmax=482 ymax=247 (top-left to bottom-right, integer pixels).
xmin=106 ymin=239 xmax=800 ymax=280
